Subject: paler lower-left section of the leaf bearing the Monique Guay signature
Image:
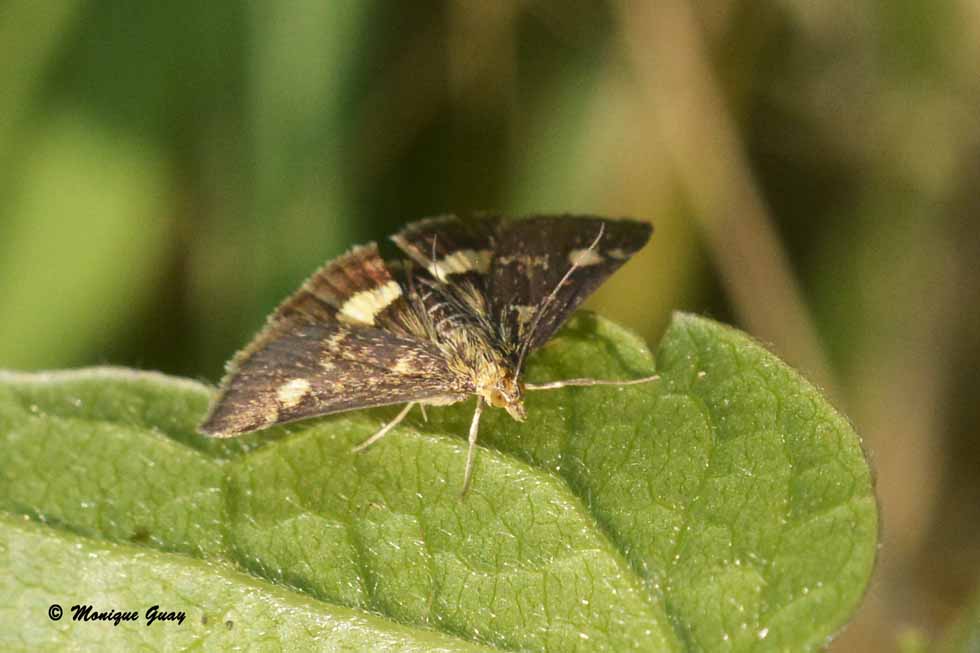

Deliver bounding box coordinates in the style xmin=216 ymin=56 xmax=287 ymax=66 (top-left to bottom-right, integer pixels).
xmin=0 ymin=515 xmax=488 ymax=652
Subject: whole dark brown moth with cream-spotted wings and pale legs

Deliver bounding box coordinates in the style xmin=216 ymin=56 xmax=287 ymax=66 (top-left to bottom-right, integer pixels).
xmin=200 ymin=215 xmax=656 ymax=494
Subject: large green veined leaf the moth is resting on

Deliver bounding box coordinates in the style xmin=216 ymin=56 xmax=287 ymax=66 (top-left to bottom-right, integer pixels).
xmin=0 ymin=315 xmax=877 ymax=651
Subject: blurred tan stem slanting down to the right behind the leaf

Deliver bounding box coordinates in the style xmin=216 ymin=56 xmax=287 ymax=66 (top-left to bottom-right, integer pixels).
xmin=618 ymin=0 xmax=842 ymax=406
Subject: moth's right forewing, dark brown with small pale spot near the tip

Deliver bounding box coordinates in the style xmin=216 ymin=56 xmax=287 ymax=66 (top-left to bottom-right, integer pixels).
xmin=489 ymin=216 xmax=653 ymax=355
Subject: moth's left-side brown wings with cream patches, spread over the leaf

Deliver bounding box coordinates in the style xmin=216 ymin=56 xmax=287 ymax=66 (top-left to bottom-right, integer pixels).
xmin=201 ymin=239 xmax=467 ymax=436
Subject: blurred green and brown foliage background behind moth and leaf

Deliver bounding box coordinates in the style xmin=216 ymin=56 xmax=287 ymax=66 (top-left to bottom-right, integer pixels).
xmin=0 ymin=0 xmax=980 ymax=651
